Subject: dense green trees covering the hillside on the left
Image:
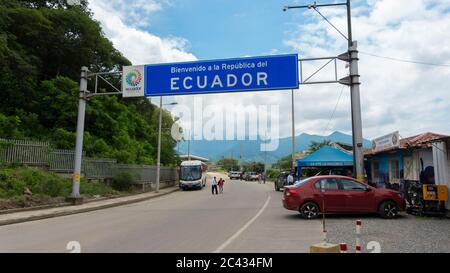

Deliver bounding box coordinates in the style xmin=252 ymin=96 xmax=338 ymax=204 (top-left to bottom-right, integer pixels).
xmin=0 ymin=0 xmax=176 ymax=165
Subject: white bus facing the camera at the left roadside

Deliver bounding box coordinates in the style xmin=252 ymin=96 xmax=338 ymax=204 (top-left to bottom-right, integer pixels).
xmin=179 ymin=160 xmax=206 ymax=190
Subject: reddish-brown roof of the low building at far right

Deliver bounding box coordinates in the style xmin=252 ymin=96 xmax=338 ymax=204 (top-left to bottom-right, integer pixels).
xmin=364 ymin=132 xmax=450 ymax=155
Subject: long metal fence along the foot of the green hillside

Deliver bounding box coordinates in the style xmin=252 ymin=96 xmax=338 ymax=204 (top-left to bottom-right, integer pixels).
xmin=0 ymin=138 xmax=177 ymax=184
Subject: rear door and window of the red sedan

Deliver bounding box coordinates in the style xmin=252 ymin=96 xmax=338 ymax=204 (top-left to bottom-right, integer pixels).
xmin=315 ymin=178 xmax=345 ymax=212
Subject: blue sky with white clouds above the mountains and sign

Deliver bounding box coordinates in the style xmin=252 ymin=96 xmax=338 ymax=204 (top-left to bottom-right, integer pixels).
xmin=90 ymin=0 xmax=450 ymax=139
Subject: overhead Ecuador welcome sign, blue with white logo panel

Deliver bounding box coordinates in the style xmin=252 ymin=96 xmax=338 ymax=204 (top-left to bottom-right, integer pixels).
xmin=122 ymin=54 xmax=299 ymax=97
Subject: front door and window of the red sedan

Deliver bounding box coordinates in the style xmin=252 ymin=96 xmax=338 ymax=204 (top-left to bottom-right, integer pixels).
xmin=339 ymin=179 xmax=375 ymax=212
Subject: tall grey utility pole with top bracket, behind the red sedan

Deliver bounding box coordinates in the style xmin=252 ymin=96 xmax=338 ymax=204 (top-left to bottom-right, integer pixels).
xmin=283 ymin=0 xmax=364 ymax=181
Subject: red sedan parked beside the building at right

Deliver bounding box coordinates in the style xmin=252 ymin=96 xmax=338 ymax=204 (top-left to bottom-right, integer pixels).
xmin=283 ymin=176 xmax=406 ymax=219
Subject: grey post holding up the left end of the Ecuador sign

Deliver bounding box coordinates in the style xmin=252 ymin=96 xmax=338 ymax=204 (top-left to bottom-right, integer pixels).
xmin=68 ymin=66 xmax=89 ymax=204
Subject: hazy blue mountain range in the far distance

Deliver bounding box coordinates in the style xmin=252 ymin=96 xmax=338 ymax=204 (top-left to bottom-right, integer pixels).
xmin=177 ymin=131 xmax=371 ymax=164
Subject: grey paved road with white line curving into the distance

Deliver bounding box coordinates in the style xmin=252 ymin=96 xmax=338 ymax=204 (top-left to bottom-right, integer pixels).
xmin=0 ymin=173 xmax=322 ymax=252
